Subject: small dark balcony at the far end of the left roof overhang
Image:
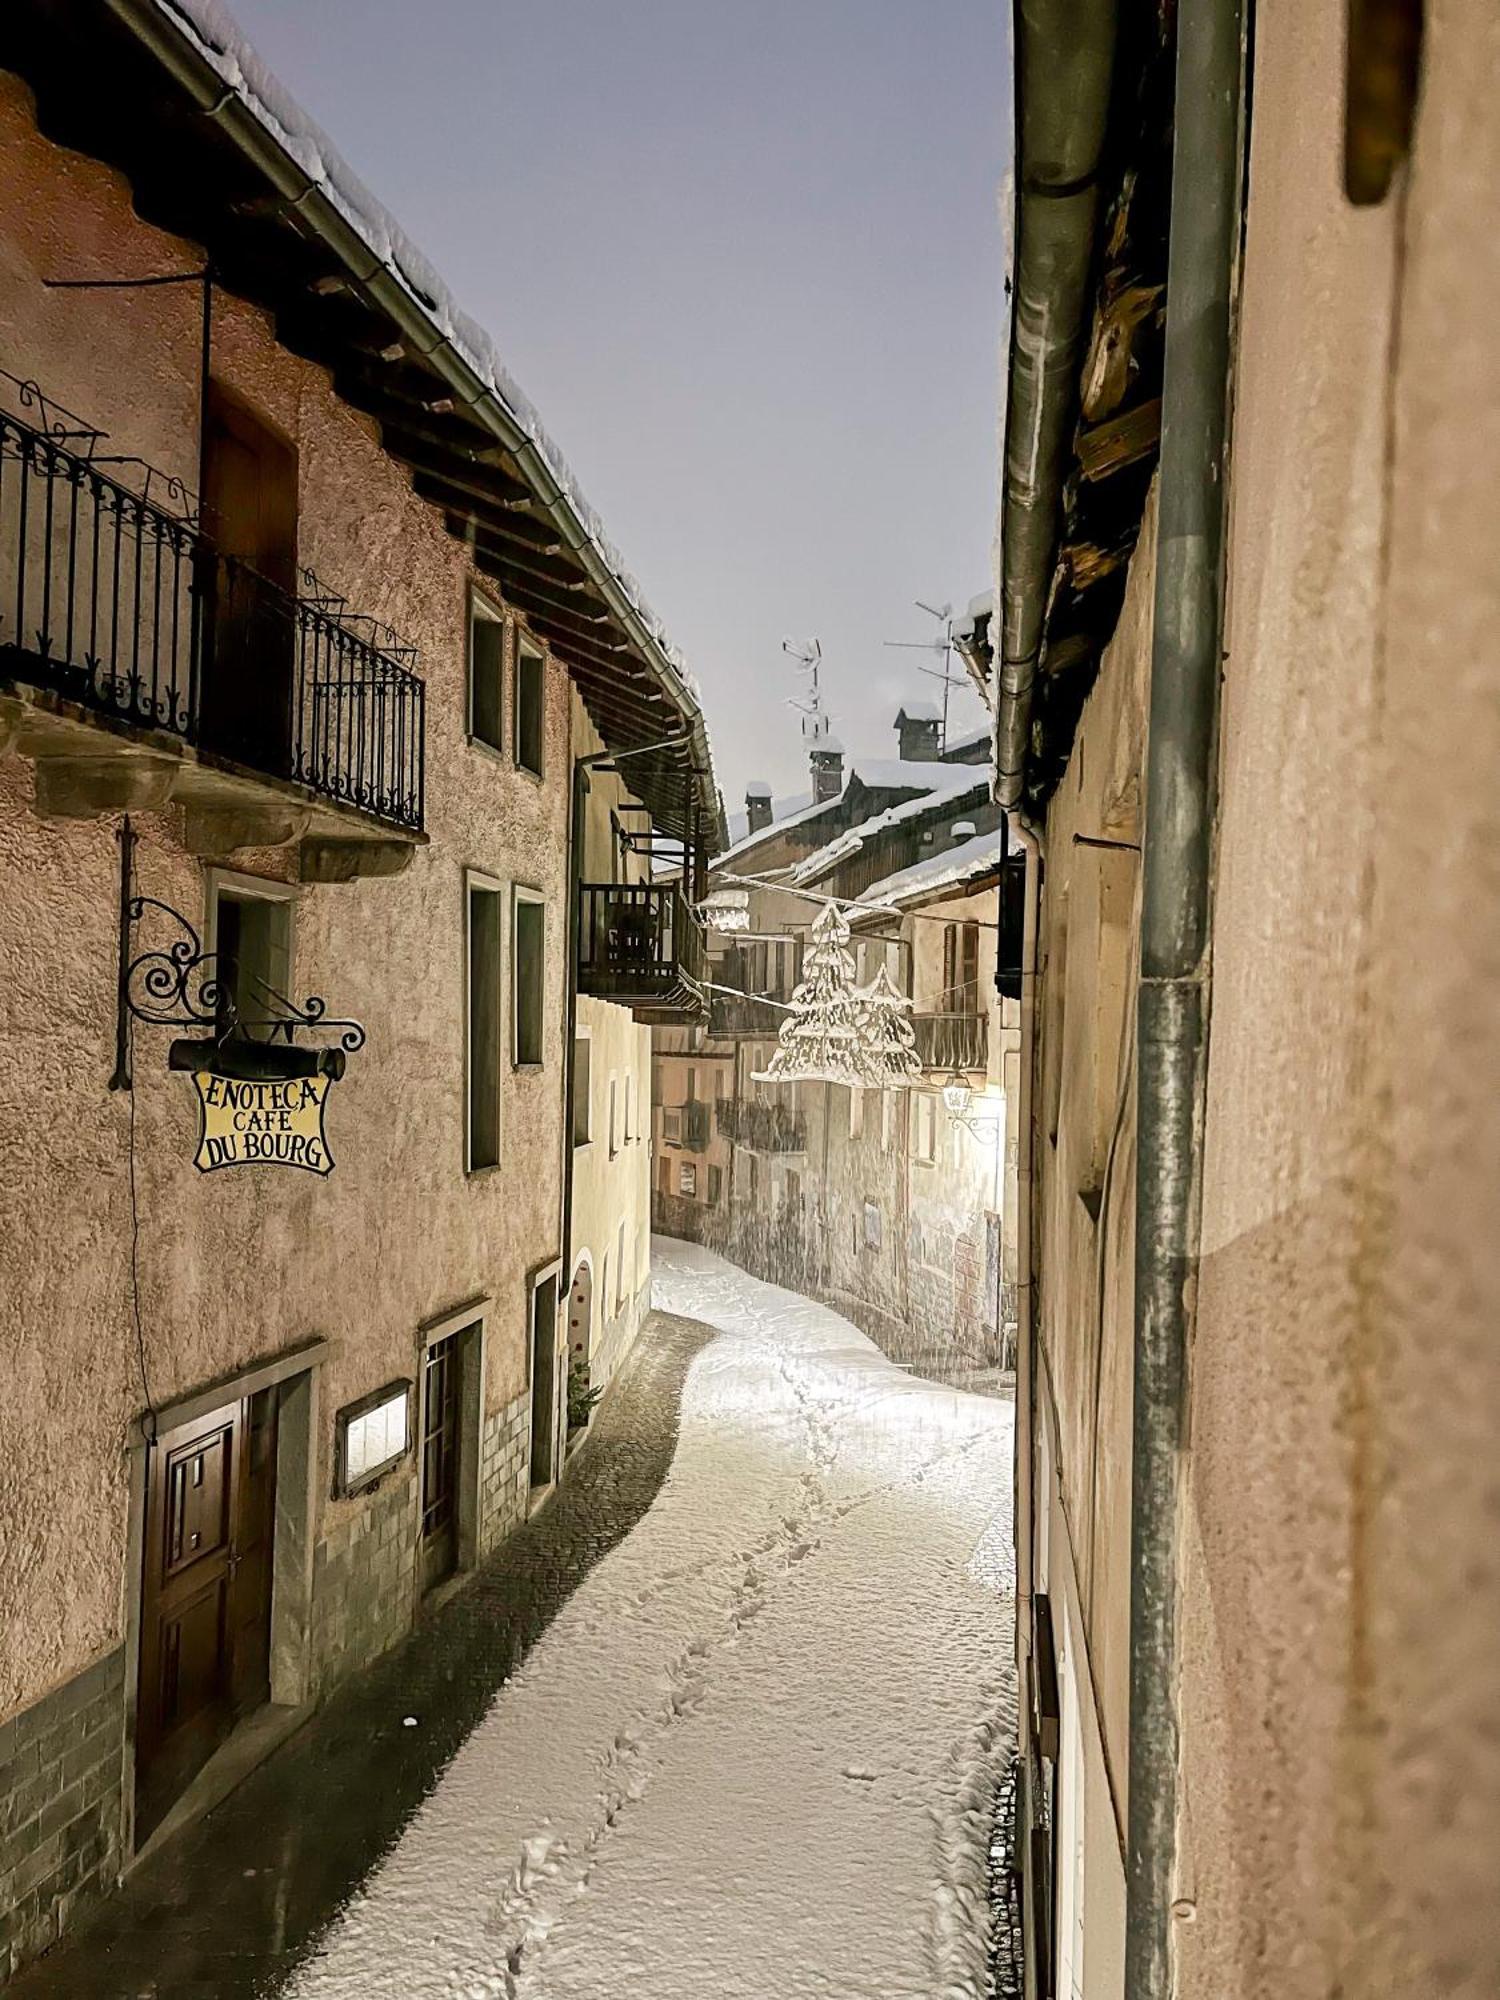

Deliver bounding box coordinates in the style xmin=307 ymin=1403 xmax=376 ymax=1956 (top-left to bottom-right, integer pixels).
xmin=578 ymin=882 xmax=706 ymax=1024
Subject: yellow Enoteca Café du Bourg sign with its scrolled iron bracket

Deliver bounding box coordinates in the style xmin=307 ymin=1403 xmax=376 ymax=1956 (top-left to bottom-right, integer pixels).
xmin=110 ymin=820 xmax=364 ymax=1176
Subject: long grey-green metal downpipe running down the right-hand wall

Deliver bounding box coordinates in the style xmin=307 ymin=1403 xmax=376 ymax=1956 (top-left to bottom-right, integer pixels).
xmin=1126 ymin=0 xmax=1244 ymax=2000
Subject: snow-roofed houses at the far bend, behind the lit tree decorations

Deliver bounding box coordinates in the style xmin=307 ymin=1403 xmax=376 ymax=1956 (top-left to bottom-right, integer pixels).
xmin=652 ymin=728 xmax=1016 ymax=1378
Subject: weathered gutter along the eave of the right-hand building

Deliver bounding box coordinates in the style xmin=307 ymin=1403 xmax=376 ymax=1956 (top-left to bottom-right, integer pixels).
xmin=992 ymin=0 xmax=1118 ymax=806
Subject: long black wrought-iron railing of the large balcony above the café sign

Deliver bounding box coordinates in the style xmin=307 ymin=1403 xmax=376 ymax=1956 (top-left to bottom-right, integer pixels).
xmin=0 ymin=412 xmax=426 ymax=830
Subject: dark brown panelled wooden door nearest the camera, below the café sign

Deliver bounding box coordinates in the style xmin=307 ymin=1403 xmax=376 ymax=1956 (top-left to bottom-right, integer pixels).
xmin=136 ymin=1390 xmax=276 ymax=1834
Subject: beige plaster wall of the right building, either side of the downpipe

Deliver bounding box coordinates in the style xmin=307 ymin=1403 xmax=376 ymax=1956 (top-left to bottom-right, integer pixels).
xmin=1032 ymin=0 xmax=1500 ymax=2000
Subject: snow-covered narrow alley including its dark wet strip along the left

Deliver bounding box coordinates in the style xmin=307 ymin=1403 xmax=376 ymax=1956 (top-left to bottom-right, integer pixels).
xmin=14 ymin=1238 xmax=1014 ymax=2000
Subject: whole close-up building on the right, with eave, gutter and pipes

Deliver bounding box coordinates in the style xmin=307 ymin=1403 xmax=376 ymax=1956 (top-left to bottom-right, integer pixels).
xmin=988 ymin=0 xmax=1500 ymax=2000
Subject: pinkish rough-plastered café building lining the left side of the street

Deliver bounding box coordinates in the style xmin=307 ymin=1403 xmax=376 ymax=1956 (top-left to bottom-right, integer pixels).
xmin=0 ymin=4 xmax=718 ymax=1970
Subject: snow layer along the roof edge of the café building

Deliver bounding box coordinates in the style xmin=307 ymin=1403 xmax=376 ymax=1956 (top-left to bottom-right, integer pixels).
xmin=156 ymin=0 xmax=700 ymax=700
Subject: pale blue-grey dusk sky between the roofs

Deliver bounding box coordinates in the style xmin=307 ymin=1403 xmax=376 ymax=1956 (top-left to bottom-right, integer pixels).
xmin=232 ymin=0 xmax=1010 ymax=812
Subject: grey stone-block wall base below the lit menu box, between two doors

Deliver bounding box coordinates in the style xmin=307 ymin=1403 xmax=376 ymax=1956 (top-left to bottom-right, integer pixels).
xmin=312 ymin=1460 xmax=416 ymax=1694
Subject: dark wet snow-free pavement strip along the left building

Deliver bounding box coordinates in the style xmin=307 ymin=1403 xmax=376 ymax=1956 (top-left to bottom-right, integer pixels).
xmin=6 ymin=1312 xmax=712 ymax=2000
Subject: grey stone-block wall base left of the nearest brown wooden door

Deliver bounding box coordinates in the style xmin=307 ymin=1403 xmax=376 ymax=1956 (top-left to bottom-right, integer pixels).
xmin=0 ymin=1646 xmax=124 ymax=1982
